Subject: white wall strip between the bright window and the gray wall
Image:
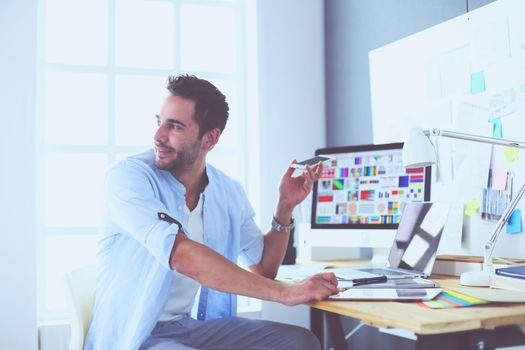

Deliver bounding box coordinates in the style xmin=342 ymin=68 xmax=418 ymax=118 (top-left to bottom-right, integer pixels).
xmin=257 ymin=0 xmax=325 ymax=224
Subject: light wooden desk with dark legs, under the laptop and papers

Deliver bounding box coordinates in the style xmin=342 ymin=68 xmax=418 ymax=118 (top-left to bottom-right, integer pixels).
xmin=311 ymin=276 xmax=525 ymax=350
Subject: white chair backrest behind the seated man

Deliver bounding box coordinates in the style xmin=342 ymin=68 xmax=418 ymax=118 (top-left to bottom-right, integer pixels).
xmin=66 ymin=266 xmax=97 ymax=350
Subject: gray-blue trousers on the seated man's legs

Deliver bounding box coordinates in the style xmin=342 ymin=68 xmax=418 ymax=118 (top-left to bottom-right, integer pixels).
xmin=140 ymin=317 xmax=321 ymax=350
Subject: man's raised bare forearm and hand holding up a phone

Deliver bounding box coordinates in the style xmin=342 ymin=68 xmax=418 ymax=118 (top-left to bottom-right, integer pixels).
xmin=250 ymin=163 xmax=323 ymax=279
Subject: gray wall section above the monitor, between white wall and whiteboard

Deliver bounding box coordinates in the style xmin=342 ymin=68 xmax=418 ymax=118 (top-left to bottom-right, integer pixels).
xmin=325 ymin=0 xmax=468 ymax=146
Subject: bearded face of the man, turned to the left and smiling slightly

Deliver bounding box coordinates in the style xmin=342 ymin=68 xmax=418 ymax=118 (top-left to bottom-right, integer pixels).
xmin=154 ymin=95 xmax=202 ymax=171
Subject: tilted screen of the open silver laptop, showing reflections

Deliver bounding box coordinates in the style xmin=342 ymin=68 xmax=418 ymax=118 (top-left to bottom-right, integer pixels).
xmin=388 ymin=202 xmax=449 ymax=274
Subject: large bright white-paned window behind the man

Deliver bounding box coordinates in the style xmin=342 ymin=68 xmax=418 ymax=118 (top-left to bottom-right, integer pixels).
xmin=37 ymin=0 xmax=256 ymax=319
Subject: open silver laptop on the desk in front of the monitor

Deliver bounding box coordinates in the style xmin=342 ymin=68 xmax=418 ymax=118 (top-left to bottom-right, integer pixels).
xmin=326 ymin=202 xmax=449 ymax=280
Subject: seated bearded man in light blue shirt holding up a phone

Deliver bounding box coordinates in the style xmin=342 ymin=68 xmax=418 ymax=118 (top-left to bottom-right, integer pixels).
xmin=86 ymin=75 xmax=338 ymax=350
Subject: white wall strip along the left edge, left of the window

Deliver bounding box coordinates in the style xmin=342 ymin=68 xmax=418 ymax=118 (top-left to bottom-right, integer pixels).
xmin=0 ymin=0 xmax=37 ymax=350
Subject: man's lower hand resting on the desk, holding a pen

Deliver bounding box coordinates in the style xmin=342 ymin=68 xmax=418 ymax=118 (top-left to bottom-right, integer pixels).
xmin=280 ymin=272 xmax=339 ymax=306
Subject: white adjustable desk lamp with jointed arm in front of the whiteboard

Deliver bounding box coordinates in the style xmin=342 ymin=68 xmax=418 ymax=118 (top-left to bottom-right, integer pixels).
xmin=403 ymin=128 xmax=525 ymax=286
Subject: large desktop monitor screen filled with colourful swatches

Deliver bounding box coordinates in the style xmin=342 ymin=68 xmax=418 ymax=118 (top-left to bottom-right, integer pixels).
xmin=311 ymin=143 xmax=431 ymax=229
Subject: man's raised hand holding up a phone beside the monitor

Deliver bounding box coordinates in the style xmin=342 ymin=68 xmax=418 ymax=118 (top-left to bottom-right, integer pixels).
xmin=278 ymin=160 xmax=323 ymax=213
